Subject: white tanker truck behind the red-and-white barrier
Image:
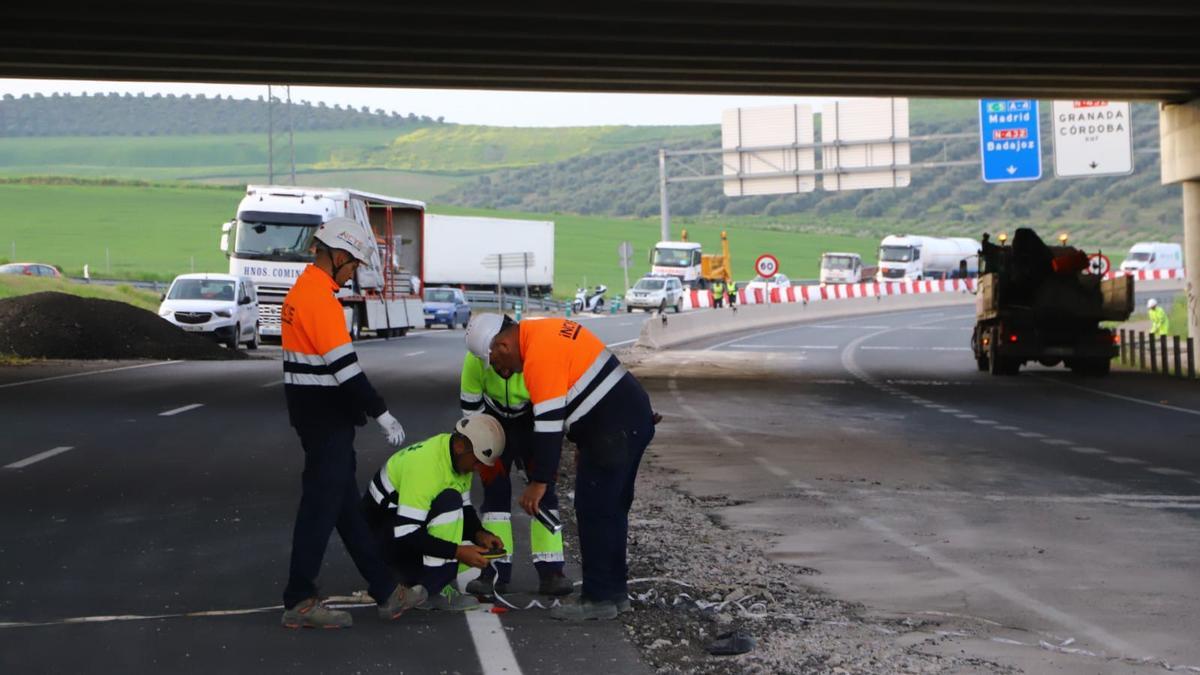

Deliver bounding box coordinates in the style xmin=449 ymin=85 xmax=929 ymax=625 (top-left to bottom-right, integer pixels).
xmin=875 ymin=234 xmax=979 ymax=281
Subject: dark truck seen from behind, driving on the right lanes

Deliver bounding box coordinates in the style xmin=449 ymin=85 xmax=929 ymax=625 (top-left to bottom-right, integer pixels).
xmin=971 ymin=228 xmax=1134 ymax=376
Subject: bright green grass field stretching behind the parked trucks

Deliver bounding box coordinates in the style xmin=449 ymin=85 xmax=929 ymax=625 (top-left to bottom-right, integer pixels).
xmin=0 ymin=184 xmax=877 ymax=295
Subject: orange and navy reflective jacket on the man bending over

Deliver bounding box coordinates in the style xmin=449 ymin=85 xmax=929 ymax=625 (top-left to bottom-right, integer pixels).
xmin=518 ymin=318 xmax=625 ymax=483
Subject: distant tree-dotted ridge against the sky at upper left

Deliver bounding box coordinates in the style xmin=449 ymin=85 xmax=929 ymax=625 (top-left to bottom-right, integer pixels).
xmin=0 ymin=92 xmax=444 ymax=137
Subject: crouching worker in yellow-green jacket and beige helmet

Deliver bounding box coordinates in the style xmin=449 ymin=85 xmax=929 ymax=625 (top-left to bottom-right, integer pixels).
xmin=362 ymin=414 xmax=504 ymax=610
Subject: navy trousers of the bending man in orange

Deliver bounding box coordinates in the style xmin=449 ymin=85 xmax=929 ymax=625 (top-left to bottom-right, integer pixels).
xmin=570 ymin=374 xmax=654 ymax=602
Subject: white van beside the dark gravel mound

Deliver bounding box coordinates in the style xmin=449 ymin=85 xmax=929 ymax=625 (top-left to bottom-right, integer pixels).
xmin=158 ymin=274 xmax=259 ymax=350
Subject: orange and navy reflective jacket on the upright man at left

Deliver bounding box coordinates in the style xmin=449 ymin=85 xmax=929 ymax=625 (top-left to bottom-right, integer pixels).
xmin=280 ymin=265 xmax=388 ymax=429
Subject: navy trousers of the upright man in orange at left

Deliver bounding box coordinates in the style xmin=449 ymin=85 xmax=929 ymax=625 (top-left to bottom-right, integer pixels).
xmin=283 ymin=425 xmax=396 ymax=608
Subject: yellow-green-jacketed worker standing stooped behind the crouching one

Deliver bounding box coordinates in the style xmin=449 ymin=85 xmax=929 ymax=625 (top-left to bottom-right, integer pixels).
xmin=460 ymin=315 xmax=574 ymax=596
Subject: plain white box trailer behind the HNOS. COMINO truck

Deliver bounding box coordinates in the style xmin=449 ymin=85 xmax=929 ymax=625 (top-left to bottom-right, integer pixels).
xmin=424 ymin=214 xmax=554 ymax=295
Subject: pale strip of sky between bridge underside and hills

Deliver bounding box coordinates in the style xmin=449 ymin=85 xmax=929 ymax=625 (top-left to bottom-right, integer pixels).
xmin=0 ymin=79 xmax=820 ymax=126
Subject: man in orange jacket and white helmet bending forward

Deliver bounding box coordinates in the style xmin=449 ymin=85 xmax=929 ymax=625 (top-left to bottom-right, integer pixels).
xmin=467 ymin=315 xmax=654 ymax=621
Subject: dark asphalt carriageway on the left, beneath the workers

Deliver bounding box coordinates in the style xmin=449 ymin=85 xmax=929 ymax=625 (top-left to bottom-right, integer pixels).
xmin=0 ymin=315 xmax=642 ymax=673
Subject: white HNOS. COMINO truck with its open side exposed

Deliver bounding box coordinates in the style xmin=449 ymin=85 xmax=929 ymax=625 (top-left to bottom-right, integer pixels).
xmin=221 ymin=185 xmax=425 ymax=338
